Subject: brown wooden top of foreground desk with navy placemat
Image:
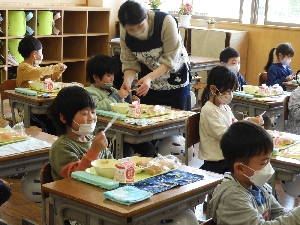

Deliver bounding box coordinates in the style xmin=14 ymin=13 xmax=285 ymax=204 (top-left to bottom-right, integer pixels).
xmin=42 ymin=165 xmax=223 ymax=218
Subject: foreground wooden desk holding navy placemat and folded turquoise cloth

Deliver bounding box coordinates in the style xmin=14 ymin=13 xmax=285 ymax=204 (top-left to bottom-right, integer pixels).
xmin=42 ymin=165 xmax=223 ymax=225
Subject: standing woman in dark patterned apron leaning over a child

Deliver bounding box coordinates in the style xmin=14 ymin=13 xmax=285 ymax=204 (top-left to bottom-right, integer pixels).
xmin=118 ymin=1 xmax=191 ymax=110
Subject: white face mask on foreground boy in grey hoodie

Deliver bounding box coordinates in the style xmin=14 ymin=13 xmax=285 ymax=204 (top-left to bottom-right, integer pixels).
xmin=241 ymin=163 xmax=275 ymax=187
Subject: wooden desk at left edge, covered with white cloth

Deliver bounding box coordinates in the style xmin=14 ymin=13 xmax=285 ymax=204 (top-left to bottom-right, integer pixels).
xmin=0 ymin=128 xmax=57 ymax=177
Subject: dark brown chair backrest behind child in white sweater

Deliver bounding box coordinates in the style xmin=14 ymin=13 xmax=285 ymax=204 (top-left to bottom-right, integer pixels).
xmin=184 ymin=113 xmax=200 ymax=165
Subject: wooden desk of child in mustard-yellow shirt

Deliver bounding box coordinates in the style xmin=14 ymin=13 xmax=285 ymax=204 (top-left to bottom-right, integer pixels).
xmin=5 ymin=90 xmax=54 ymax=128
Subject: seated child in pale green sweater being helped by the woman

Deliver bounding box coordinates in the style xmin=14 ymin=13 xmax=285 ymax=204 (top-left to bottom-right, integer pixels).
xmin=86 ymin=54 xmax=156 ymax=157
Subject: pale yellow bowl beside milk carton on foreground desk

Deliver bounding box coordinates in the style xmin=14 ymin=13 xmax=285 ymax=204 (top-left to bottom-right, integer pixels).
xmin=91 ymin=159 xmax=120 ymax=179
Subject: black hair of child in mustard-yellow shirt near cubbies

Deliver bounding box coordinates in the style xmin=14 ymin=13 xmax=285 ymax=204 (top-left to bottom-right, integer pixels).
xmin=18 ymin=36 xmax=43 ymax=59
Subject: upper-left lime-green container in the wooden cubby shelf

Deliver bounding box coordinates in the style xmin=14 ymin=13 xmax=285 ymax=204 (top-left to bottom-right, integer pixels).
xmin=8 ymin=11 xmax=26 ymax=36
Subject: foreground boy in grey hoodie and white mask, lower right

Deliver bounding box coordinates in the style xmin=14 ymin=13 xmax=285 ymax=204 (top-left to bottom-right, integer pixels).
xmin=208 ymin=121 xmax=300 ymax=225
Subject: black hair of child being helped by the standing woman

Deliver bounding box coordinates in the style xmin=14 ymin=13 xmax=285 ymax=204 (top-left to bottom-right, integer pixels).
xmin=86 ymin=54 xmax=119 ymax=84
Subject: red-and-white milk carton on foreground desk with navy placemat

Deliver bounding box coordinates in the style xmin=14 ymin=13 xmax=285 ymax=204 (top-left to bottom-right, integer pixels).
xmin=114 ymin=159 xmax=135 ymax=183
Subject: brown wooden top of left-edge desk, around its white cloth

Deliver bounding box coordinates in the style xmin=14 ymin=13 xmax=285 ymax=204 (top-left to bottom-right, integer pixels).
xmin=0 ymin=128 xmax=57 ymax=163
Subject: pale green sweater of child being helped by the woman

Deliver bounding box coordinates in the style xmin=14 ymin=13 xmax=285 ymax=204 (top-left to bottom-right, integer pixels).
xmin=85 ymin=84 xmax=118 ymax=111
